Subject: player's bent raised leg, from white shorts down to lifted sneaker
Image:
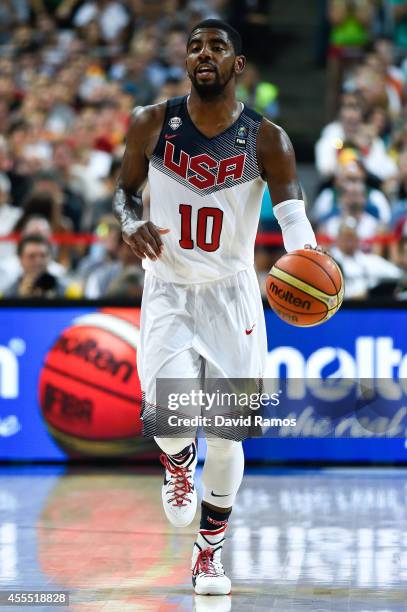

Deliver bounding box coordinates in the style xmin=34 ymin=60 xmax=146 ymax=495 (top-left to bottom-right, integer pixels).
xmin=137 ymin=274 xmax=202 ymax=527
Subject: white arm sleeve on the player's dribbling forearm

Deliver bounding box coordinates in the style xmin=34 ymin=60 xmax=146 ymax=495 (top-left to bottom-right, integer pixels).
xmin=273 ymin=200 xmax=317 ymax=253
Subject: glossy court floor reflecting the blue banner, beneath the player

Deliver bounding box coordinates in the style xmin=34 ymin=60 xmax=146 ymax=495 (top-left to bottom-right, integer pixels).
xmin=0 ymin=467 xmax=407 ymax=612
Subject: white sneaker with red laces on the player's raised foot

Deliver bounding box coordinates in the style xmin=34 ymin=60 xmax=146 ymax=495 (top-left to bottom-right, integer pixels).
xmin=160 ymin=444 xmax=197 ymax=527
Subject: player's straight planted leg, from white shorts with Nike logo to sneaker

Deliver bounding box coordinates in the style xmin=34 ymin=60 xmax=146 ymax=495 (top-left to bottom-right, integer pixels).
xmin=192 ymin=270 xmax=267 ymax=595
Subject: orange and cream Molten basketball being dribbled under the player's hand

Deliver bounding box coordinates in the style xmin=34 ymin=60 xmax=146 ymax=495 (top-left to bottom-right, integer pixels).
xmin=266 ymin=249 xmax=344 ymax=327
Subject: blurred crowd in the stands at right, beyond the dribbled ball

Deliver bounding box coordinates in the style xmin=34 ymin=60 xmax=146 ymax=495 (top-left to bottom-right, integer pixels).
xmin=309 ymin=0 xmax=407 ymax=299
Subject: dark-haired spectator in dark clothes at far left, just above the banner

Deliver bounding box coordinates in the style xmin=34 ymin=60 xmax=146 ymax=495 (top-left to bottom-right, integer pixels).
xmin=4 ymin=234 xmax=65 ymax=298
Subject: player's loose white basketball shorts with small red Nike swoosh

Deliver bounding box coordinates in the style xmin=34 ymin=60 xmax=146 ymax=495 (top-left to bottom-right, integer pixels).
xmin=137 ymin=268 xmax=267 ymax=394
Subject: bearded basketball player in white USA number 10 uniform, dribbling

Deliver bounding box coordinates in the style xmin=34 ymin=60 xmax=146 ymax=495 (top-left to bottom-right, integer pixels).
xmin=114 ymin=19 xmax=316 ymax=595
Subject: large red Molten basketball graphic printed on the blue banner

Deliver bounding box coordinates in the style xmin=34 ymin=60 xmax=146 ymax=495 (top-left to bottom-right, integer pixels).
xmin=39 ymin=308 xmax=154 ymax=457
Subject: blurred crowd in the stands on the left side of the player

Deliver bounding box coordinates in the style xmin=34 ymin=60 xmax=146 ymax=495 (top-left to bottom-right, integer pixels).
xmin=0 ymin=0 xmax=278 ymax=298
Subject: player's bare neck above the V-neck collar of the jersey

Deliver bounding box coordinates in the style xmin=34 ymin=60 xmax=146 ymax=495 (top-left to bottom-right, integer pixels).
xmin=187 ymin=89 xmax=242 ymax=131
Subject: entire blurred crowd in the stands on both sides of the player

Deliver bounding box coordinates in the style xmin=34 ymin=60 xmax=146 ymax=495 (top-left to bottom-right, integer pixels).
xmin=0 ymin=0 xmax=407 ymax=299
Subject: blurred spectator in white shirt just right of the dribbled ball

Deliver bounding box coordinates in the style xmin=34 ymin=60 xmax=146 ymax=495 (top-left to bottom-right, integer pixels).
xmin=331 ymin=217 xmax=404 ymax=299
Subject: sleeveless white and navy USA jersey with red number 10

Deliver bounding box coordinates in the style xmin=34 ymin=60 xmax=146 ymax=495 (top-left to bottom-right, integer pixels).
xmin=143 ymin=97 xmax=265 ymax=284
